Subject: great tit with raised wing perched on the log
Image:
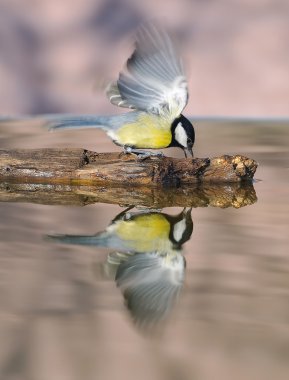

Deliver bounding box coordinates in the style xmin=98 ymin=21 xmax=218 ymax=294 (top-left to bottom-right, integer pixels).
xmin=46 ymin=23 xmax=195 ymax=157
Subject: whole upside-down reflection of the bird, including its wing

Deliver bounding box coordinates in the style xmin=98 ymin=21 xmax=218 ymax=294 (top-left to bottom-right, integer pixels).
xmin=48 ymin=207 xmax=193 ymax=328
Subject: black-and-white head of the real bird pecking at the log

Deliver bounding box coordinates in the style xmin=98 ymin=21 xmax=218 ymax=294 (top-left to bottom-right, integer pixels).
xmin=170 ymin=115 xmax=195 ymax=157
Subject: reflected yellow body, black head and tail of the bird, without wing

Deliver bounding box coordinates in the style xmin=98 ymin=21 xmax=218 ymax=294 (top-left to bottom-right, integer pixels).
xmin=47 ymin=206 xmax=193 ymax=253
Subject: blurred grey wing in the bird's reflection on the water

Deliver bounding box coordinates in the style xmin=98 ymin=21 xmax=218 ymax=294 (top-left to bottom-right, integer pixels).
xmin=116 ymin=253 xmax=184 ymax=327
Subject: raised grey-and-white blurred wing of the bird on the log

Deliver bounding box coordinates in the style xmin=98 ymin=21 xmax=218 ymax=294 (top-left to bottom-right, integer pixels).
xmin=107 ymin=23 xmax=188 ymax=119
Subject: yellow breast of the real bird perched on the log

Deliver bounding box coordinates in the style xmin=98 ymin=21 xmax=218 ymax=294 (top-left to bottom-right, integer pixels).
xmin=116 ymin=114 xmax=172 ymax=149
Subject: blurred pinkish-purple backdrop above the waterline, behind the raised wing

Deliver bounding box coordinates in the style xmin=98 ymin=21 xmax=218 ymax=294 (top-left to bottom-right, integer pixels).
xmin=0 ymin=0 xmax=289 ymax=117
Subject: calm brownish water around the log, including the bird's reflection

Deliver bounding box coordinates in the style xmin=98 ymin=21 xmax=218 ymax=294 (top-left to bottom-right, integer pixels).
xmin=0 ymin=120 xmax=289 ymax=380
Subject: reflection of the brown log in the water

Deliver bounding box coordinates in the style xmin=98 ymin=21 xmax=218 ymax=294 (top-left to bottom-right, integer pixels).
xmin=0 ymin=182 xmax=257 ymax=208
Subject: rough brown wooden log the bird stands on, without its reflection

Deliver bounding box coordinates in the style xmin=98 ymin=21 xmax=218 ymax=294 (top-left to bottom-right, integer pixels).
xmin=0 ymin=149 xmax=257 ymax=187
